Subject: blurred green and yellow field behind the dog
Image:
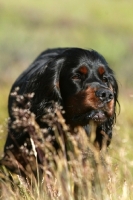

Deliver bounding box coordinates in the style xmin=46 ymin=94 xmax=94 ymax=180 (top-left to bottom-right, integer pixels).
xmin=0 ymin=0 xmax=133 ymax=162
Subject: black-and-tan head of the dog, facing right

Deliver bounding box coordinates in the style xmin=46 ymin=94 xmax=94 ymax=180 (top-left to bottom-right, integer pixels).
xmin=59 ymin=49 xmax=118 ymax=128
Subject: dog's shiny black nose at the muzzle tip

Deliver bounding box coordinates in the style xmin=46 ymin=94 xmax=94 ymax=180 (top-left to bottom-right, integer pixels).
xmin=95 ymin=89 xmax=114 ymax=103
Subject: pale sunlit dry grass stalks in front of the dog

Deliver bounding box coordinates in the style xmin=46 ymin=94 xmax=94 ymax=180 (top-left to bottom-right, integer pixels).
xmin=0 ymin=96 xmax=133 ymax=200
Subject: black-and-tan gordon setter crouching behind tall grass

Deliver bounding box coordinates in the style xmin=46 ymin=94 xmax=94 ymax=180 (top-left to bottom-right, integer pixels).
xmin=5 ymin=48 xmax=118 ymax=154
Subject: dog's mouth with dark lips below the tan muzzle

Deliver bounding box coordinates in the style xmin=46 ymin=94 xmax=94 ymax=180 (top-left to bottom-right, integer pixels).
xmin=73 ymin=110 xmax=107 ymax=124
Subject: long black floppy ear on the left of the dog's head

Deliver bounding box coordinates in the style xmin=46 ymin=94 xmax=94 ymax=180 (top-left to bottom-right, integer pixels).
xmin=28 ymin=58 xmax=63 ymax=116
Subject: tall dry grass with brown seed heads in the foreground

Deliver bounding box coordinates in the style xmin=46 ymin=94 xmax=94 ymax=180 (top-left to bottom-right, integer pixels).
xmin=0 ymin=93 xmax=133 ymax=200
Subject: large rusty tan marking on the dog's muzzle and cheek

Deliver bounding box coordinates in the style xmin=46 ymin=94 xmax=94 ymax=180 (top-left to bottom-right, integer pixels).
xmin=65 ymin=87 xmax=114 ymax=125
